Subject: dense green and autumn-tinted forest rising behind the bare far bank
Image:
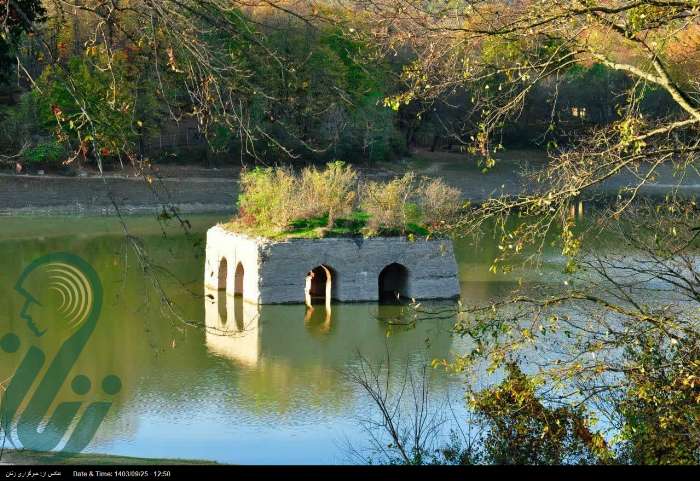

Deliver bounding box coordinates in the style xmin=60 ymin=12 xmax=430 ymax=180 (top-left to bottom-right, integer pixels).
xmin=0 ymin=0 xmax=680 ymax=171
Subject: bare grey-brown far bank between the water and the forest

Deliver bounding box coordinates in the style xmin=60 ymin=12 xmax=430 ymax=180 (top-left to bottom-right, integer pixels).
xmin=0 ymin=151 xmax=700 ymax=216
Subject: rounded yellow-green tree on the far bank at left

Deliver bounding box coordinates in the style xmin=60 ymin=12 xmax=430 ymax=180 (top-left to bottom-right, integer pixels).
xmin=32 ymin=45 xmax=167 ymax=163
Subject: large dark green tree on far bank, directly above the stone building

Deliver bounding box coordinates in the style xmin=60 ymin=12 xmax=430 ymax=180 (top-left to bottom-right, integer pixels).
xmin=251 ymin=25 xmax=405 ymax=160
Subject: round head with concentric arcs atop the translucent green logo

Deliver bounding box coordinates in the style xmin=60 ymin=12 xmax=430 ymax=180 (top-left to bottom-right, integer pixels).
xmin=15 ymin=261 xmax=94 ymax=337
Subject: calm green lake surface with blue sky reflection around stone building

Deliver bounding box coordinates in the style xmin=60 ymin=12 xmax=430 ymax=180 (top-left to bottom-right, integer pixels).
xmin=0 ymin=216 xmax=561 ymax=464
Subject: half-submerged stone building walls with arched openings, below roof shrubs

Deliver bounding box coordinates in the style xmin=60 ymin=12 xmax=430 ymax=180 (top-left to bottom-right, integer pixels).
xmin=204 ymin=225 xmax=459 ymax=304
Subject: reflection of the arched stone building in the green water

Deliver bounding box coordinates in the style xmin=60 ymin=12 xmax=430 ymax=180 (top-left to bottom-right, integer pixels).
xmin=204 ymin=284 xmax=460 ymax=370
